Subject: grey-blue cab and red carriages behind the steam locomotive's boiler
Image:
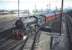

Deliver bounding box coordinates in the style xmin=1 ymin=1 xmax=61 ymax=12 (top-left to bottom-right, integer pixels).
xmin=35 ymin=13 xmax=61 ymax=26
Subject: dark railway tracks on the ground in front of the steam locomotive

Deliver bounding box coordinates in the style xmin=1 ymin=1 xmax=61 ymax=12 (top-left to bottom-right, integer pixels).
xmin=0 ymin=27 xmax=39 ymax=50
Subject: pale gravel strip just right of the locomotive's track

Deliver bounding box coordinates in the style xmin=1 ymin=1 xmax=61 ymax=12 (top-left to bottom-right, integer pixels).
xmin=36 ymin=31 xmax=50 ymax=50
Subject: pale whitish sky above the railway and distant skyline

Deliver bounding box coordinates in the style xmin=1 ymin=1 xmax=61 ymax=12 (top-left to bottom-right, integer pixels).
xmin=0 ymin=0 xmax=72 ymax=11
